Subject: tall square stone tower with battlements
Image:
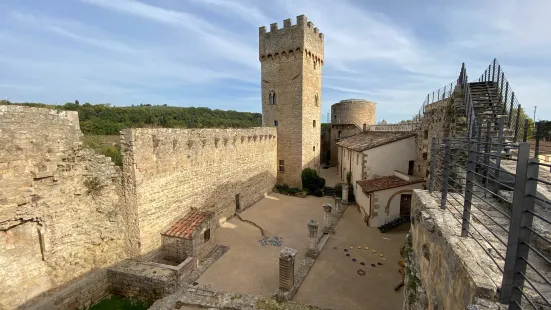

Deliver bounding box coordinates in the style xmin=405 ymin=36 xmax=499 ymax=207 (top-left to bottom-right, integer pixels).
xmin=259 ymin=15 xmax=323 ymax=187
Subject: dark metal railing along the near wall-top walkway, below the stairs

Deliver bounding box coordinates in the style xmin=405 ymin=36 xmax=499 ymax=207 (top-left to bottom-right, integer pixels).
xmin=428 ymin=117 xmax=551 ymax=309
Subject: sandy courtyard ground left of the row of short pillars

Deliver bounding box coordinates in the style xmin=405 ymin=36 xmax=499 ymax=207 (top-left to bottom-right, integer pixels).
xmin=197 ymin=193 xmax=333 ymax=296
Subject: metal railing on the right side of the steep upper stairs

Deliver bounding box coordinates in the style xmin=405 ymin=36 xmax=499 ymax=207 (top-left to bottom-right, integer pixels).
xmin=478 ymin=58 xmax=526 ymax=141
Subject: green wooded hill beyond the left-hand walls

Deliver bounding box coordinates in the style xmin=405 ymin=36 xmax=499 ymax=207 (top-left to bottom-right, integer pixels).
xmin=0 ymin=100 xmax=262 ymax=135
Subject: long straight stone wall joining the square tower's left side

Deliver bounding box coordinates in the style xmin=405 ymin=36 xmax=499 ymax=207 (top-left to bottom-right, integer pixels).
xmin=122 ymin=128 xmax=277 ymax=255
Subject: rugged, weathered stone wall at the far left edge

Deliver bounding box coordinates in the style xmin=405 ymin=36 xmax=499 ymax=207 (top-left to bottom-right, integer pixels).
xmin=0 ymin=106 xmax=126 ymax=309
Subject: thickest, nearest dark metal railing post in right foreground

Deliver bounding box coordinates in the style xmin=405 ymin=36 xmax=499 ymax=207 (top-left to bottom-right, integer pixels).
xmin=500 ymin=142 xmax=538 ymax=310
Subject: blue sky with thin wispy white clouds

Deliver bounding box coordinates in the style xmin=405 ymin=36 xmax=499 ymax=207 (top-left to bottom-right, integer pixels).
xmin=0 ymin=0 xmax=551 ymax=122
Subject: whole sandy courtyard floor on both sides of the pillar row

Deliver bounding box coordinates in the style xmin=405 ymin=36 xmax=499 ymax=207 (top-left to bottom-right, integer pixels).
xmin=197 ymin=188 xmax=409 ymax=310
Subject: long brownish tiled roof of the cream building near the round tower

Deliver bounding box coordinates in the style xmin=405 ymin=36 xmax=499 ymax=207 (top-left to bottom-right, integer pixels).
xmin=337 ymin=131 xmax=415 ymax=152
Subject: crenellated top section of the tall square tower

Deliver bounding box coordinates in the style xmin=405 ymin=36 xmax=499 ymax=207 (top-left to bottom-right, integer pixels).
xmin=259 ymin=15 xmax=324 ymax=65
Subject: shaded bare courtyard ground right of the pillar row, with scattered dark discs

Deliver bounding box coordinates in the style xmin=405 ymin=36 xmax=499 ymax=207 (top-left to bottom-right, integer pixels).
xmin=293 ymin=206 xmax=409 ymax=310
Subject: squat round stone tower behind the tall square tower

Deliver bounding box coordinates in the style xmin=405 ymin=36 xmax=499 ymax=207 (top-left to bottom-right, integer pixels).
xmin=330 ymin=99 xmax=376 ymax=165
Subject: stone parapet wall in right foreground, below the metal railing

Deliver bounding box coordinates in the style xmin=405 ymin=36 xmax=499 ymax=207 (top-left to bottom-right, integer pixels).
xmin=403 ymin=190 xmax=499 ymax=310
